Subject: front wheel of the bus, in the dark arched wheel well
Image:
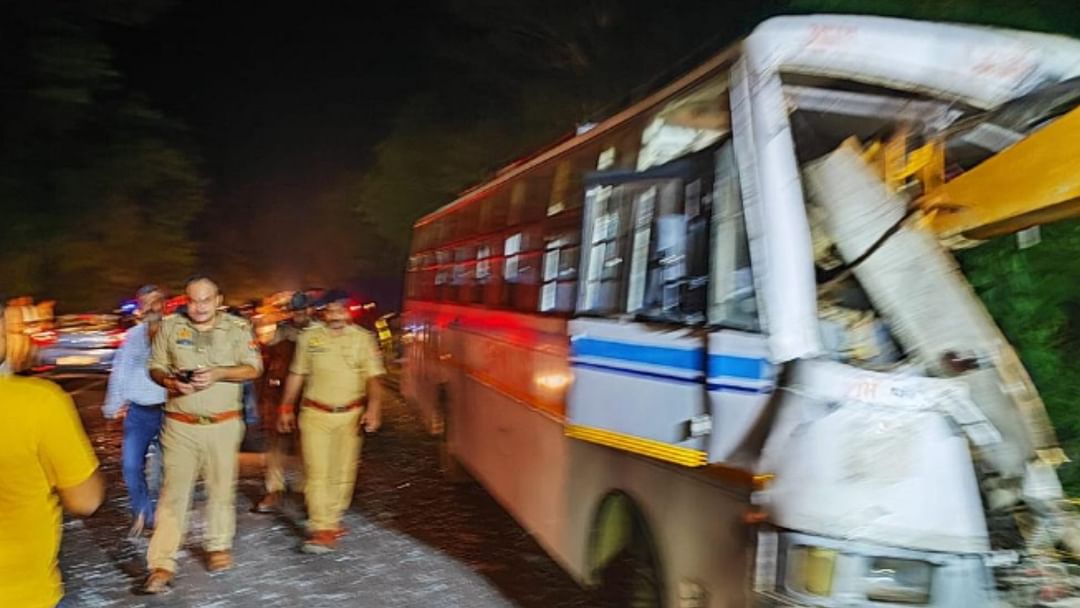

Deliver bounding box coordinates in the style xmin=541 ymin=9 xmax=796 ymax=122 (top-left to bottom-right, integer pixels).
xmin=590 ymin=492 xmax=664 ymax=608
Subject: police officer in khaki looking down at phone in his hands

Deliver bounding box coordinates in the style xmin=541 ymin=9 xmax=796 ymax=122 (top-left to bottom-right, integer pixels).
xmin=144 ymin=275 xmax=262 ymax=593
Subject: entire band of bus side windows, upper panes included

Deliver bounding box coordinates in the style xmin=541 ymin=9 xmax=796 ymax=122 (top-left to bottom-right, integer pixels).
xmin=406 ymin=76 xmax=758 ymax=330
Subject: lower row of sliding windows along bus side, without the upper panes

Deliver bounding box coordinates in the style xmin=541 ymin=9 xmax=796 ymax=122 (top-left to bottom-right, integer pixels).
xmin=406 ymin=144 xmax=758 ymax=330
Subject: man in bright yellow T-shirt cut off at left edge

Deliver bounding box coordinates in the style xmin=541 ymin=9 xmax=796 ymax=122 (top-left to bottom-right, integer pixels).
xmin=0 ymin=309 xmax=105 ymax=608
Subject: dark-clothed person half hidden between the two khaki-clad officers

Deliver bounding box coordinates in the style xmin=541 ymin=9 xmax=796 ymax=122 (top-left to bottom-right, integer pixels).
xmin=254 ymin=292 xmax=312 ymax=513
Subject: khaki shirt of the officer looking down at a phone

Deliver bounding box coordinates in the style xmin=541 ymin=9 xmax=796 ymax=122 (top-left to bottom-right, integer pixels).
xmin=150 ymin=312 xmax=262 ymax=416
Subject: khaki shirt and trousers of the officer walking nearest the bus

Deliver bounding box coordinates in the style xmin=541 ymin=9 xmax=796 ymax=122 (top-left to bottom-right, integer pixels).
xmin=289 ymin=324 xmax=386 ymax=532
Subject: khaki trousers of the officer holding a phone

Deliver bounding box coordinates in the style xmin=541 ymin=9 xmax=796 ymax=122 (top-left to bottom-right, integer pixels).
xmin=147 ymin=418 xmax=244 ymax=572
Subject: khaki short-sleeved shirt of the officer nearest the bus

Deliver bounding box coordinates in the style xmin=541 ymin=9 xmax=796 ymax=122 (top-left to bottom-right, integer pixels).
xmin=288 ymin=323 xmax=387 ymax=407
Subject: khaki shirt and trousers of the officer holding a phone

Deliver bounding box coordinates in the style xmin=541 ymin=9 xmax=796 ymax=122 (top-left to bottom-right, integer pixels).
xmin=147 ymin=313 xmax=262 ymax=572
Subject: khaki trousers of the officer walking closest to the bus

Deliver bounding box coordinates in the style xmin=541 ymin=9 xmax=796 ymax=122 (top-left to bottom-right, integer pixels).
xmin=299 ymin=407 xmax=363 ymax=532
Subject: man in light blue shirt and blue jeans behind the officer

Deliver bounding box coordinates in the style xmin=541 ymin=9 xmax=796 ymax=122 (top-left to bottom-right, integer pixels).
xmin=103 ymin=285 xmax=165 ymax=536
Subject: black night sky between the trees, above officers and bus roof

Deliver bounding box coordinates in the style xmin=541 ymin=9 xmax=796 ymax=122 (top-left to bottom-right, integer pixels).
xmin=99 ymin=0 xmax=760 ymax=304
